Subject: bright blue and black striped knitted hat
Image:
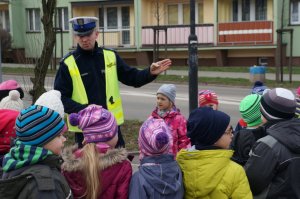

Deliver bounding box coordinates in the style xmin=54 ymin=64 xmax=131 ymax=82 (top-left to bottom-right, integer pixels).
xmin=16 ymin=105 xmax=66 ymax=146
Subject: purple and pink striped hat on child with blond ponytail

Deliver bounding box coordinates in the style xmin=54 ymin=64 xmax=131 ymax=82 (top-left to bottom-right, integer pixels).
xmin=69 ymin=105 xmax=118 ymax=143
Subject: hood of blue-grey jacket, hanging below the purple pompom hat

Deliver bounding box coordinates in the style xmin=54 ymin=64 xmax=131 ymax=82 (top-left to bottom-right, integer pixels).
xmin=139 ymin=154 xmax=183 ymax=195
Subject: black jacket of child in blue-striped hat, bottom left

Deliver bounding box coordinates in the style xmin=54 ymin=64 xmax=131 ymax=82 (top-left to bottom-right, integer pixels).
xmin=0 ymin=155 xmax=73 ymax=199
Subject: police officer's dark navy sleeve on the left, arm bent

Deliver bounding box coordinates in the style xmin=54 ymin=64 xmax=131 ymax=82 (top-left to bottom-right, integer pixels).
xmin=54 ymin=57 xmax=87 ymax=114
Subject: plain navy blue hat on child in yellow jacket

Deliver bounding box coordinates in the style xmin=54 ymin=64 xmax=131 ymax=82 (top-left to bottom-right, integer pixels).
xmin=187 ymin=107 xmax=230 ymax=147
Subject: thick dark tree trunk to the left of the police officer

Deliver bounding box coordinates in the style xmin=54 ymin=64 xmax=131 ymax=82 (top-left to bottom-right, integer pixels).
xmin=30 ymin=0 xmax=56 ymax=103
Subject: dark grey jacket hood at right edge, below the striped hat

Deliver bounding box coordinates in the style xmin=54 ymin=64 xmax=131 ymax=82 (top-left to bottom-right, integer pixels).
xmin=267 ymin=118 xmax=300 ymax=154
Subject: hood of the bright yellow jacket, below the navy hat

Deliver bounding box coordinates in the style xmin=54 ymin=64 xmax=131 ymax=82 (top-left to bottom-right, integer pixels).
xmin=177 ymin=149 xmax=233 ymax=198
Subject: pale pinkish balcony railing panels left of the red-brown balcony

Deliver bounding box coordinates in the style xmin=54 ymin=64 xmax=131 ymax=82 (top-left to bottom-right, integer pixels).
xmin=142 ymin=24 xmax=214 ymax=47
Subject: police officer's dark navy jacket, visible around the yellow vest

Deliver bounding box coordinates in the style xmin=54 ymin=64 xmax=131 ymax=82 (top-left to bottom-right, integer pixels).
xmin=54 ymin=43 xmax=156 ymax=113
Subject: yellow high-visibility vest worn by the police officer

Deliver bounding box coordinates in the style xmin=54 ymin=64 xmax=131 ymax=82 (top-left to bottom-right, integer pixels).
xmin=64 ymin=49 xmax=124 ymax=132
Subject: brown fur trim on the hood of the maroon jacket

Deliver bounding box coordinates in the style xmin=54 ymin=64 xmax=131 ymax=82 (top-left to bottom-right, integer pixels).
xmin=62 ymin=146 xmax=128 ymax=172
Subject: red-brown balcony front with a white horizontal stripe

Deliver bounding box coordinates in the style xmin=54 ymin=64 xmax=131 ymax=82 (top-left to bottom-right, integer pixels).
xmin=218 ymin=21 xmax=274 ymax=45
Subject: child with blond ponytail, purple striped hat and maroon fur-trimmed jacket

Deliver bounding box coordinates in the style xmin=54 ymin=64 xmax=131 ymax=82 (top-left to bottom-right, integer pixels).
xmin=62 ymin=105 xmax=132 ymax=199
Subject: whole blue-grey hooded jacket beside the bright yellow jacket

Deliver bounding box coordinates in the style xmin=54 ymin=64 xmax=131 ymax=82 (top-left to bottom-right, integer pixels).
xmin=129 ymin=154 xmax=184 ymax=199
